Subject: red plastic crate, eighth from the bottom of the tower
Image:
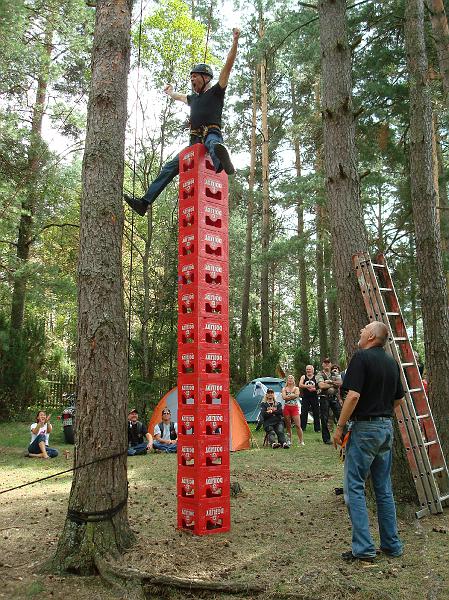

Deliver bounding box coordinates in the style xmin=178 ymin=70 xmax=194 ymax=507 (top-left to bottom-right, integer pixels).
xmin=178 ymin=285 xmax=229 ymax=319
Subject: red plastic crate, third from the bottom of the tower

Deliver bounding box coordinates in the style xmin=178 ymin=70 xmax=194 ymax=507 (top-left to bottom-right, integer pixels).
xmin=178 ymin=434 xmax=230 ymax=470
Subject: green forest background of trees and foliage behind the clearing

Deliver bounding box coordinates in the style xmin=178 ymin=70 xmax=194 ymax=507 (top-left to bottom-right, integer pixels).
xmin=0 ymin=0 xmax=449 ymax=419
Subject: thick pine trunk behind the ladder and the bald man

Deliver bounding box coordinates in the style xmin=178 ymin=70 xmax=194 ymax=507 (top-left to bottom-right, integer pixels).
xmin=319 ymin=0 xmax=416 ymax=501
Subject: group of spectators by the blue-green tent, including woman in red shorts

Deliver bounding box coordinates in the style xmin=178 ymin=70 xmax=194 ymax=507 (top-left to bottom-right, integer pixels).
xmin=260 ymin=358 xmax=343 ymax=449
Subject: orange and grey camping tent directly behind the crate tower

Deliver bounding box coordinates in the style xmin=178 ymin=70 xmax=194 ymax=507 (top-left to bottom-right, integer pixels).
xmin=148 ymin=387 xmax=250 ymax=452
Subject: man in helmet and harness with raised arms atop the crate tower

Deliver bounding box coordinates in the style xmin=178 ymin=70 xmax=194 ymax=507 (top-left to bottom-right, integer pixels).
xmin=123 ymin=28 xmax=240 ymax=216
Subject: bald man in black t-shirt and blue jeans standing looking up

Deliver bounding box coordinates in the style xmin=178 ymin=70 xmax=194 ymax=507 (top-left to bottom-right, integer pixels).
xmin=333 ymin=321 xmax=404 ymax=562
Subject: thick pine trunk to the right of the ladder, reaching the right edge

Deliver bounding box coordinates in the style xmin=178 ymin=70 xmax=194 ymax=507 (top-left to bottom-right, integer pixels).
xmin=405 ymin=0 xmax=449 ymax=457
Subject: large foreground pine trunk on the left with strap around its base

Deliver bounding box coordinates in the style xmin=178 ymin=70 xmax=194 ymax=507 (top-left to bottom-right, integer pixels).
xmin=53 ymin=0 xmax=132 ymax=575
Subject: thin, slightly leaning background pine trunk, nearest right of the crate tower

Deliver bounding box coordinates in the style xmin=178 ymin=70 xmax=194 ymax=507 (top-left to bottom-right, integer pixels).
xmin=239 ymin=65 xmax=258 ymax=383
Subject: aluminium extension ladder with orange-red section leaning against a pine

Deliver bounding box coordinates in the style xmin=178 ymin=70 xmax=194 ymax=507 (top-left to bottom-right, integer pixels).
xmin=353 ymin=253 xmax=449 ymax=518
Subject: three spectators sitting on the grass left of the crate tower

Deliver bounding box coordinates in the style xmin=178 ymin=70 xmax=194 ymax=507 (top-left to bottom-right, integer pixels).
xmin=25 ymin=407 xmax=178 ymax=459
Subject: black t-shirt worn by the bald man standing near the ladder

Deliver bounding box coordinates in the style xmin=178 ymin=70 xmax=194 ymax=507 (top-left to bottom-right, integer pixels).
xmin=343 ymin=347 xmax=404 ymax=417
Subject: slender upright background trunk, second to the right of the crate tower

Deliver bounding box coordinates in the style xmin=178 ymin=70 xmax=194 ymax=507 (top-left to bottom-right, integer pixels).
xmin=259 ymin=12 xmax=270 ymax=360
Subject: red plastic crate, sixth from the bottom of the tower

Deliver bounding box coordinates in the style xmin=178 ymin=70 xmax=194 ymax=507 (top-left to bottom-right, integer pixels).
xmin=178 ymin=344 xmax=229 ymax=382
